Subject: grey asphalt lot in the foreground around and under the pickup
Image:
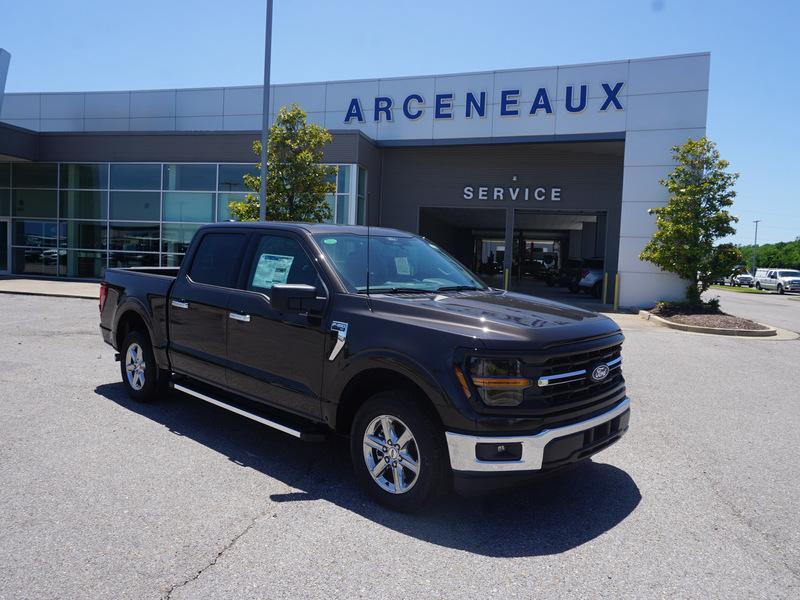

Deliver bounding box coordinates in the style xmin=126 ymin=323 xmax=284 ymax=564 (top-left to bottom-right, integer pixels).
xmin=0 ymin=295 xmax=800 ymax=599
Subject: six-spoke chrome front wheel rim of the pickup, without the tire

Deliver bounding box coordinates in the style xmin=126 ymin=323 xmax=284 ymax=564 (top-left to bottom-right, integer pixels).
xmin=363 ymin=415 xmax=420 ymax=494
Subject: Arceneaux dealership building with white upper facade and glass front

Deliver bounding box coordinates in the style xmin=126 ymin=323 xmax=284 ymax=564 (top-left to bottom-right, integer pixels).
xmin=0 ymin=50 xmax=710 ymax=306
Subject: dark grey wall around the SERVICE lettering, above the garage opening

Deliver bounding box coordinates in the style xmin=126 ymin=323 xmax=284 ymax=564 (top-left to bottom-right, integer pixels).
xmin=380 ymin=142 xmax=624 ymax=273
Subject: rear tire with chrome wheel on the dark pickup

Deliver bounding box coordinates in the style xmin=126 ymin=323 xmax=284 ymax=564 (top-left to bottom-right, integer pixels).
xmin=119 ymin=331 xmax=167 ymax=402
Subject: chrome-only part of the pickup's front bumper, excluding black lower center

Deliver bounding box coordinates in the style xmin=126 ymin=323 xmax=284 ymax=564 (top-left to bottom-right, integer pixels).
xmin=445 ymin=398 xmax=631 ymax=473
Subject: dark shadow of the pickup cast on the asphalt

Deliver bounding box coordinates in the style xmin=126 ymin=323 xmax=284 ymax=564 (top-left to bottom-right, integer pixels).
xmin=95 ymin=383 xmax=641 ymax=557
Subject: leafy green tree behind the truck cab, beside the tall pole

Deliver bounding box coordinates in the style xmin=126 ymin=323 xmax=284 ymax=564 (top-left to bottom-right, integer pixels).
xmin=229 ymin=104 xmax=336 ymax=223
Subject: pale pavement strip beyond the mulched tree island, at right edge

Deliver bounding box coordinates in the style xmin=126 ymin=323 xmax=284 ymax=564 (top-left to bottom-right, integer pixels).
xmin=705 ymin=288 xmax=800 ymax=333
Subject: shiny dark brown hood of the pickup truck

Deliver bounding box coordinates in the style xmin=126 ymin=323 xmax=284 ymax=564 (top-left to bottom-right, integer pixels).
xmin=371 ymin=290 xmax=619 ymax=350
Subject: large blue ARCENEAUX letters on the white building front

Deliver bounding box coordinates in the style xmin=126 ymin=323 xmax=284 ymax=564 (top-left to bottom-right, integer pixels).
xmin=344 ymin=81 xmax=625 ymax=123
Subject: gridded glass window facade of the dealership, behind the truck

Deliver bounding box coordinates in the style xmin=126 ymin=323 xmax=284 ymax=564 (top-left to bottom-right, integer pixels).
xmin=0 ymin=163 xmax=367 ymax=278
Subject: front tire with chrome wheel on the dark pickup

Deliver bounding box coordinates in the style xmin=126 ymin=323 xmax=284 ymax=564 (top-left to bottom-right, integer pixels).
xmin=350 ymin=390 xmax=449 ymax=512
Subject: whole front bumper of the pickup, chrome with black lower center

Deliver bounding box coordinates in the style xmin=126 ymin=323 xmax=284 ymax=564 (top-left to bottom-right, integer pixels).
xmin=445 ymin=397 xmax=630 ymax=475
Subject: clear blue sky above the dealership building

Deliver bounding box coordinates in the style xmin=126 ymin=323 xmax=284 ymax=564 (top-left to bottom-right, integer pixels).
xmin=0 ymin=0 xmax=800 ymax=242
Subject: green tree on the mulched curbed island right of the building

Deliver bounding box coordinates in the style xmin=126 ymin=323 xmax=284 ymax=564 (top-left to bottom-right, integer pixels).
xmin=639 ymin=137 xmax=744 ymax=304
